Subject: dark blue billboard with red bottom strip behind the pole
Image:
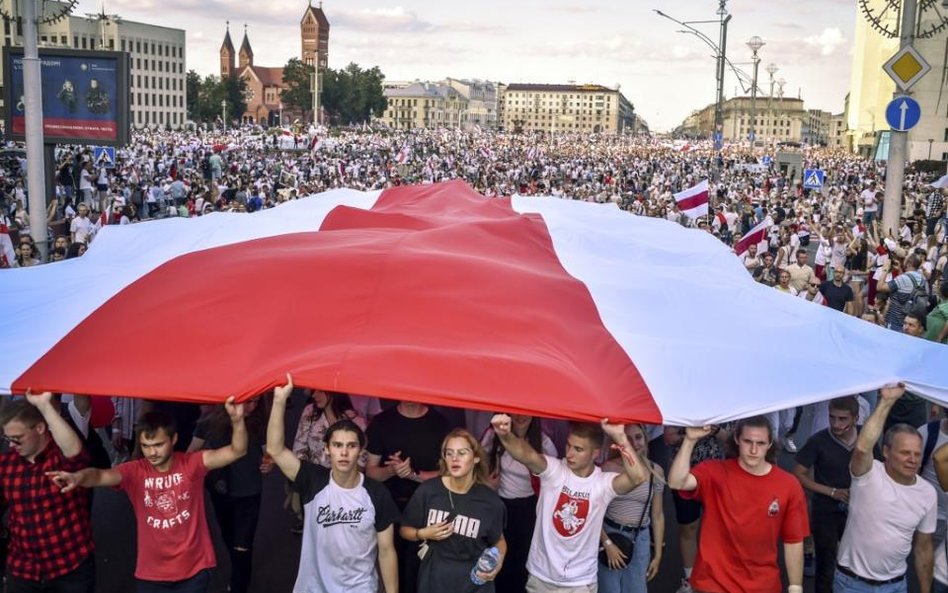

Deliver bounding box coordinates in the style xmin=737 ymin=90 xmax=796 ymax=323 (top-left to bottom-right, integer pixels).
xmin=3 ymin=47 xmax=129 ymax=146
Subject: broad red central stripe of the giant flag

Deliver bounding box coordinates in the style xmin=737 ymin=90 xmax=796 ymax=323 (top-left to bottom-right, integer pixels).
xmin=13 ymin=182 xmax=661 ymax=423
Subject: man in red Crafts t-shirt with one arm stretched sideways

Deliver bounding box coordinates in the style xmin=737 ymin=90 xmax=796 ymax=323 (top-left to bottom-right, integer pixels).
xmin=49 ymin=398 xmax=247 ymax=593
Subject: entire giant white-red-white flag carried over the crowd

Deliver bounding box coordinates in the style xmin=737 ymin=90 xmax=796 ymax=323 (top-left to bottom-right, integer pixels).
xmin=0 ymin=182 xmax=948 ymax=425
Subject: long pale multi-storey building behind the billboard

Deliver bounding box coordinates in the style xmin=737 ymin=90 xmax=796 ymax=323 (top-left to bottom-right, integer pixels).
xmin=0 ymin=0 xmax=187 ymax=128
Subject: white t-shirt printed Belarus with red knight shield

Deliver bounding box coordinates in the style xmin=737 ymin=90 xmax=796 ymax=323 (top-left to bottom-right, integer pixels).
xmin=527 ymin=455 xmax=618 ymax=587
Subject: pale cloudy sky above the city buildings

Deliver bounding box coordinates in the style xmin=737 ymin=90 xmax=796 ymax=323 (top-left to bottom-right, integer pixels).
xmin=76 ymin=0 xmax=862 ymax=132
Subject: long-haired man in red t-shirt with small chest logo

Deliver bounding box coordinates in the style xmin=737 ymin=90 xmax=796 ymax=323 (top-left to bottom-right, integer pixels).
xmin=668 ymin=416 xmax=810 ymax=593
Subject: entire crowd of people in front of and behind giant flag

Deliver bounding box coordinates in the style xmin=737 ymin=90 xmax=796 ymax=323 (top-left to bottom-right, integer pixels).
xmin=0 ymin=127 xmax=948 ymax=593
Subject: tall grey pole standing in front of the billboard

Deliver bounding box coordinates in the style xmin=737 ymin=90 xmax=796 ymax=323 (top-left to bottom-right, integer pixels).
xmin=22 ymin=0 xmax=49 ymax=260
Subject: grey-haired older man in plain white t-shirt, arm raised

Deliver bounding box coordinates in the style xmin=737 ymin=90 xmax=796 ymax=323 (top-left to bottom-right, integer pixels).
xmin=833 ymin=384 xmax=938 ymax=593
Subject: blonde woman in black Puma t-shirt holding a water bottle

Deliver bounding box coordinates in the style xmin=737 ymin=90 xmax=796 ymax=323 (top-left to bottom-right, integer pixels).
xmin=400 ymin=429 xmax=507 ymax=593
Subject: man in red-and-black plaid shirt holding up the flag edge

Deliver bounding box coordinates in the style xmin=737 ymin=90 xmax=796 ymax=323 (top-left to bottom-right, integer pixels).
xmin=0 ymin=391 xmax=95 ymax=593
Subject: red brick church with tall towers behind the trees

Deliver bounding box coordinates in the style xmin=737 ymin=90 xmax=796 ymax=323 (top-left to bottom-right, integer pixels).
xmin=221 ymin=2 xmax=329 ymax=126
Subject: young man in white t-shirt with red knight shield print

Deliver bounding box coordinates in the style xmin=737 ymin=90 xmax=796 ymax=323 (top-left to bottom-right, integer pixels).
xmin=491 ymin=414 xmax=648 ymax=593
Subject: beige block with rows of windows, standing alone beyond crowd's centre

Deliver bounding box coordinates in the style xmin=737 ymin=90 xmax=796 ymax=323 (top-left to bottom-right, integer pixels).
xmin=501 ymin=84 xmax=635 ymax=134
